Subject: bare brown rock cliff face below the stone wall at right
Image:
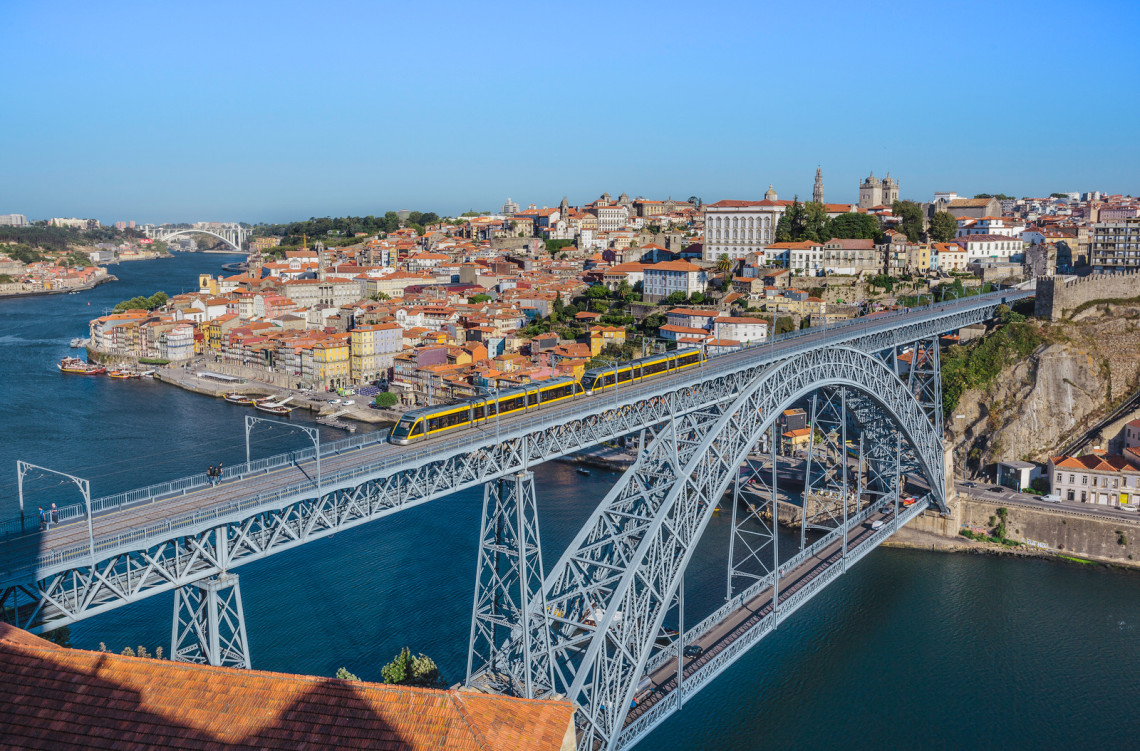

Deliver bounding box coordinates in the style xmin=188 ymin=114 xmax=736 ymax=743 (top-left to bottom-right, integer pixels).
xmin=946 ymin=308 xmax=1140 ymax=476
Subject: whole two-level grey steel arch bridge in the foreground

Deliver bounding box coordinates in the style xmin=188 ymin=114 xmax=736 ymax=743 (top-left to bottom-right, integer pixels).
xmin=0 ymin=291 xmax=1033 ymax=750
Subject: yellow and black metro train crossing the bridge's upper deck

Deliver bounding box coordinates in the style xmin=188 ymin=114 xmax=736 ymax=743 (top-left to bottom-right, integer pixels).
xmin=389 ymin=349 xmax=703 ymax=446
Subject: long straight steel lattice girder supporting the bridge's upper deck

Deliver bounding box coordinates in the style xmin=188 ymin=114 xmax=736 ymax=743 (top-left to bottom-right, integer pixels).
xmin=0 ymin=292 xmax=1032 ymax=632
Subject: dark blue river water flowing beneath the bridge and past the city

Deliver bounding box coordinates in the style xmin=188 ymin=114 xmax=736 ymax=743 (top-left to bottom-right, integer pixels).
xmin=0 ymin=254 xmax=1140 ymax=750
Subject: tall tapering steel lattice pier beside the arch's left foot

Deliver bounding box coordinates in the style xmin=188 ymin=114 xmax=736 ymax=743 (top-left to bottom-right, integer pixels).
xmin=467 ymin=472 xmax=553 ymax=699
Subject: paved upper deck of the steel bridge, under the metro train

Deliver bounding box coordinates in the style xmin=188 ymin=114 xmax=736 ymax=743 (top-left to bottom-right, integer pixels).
xmin=0 ymin=292 xmax=1032 ymax=578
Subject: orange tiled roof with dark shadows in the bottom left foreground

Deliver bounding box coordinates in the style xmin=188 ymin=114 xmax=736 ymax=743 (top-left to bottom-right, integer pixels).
xmin=0 ymin=623 xmax=573 ymax=751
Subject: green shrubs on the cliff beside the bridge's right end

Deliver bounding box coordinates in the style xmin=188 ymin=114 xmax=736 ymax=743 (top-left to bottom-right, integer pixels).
xmin=942 ymin=321 xmax=1045 ymax=417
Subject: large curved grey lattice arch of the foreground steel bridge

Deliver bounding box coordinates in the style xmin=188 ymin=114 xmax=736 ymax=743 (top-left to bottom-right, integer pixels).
xmin=532 ymin=348 xmax=945 ymax=749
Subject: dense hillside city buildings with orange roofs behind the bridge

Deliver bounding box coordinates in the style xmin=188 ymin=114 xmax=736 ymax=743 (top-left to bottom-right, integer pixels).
xmin=46 ymin=169 xmax=1140 ymax=417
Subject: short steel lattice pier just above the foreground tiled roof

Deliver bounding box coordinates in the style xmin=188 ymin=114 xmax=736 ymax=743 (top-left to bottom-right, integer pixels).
xmin=170 ymin=572 xmax=251 ymax=669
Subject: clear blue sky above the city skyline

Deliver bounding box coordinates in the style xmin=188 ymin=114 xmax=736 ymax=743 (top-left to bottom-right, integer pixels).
xmin=0 ymin=0 xmax=1140 ymax=221
